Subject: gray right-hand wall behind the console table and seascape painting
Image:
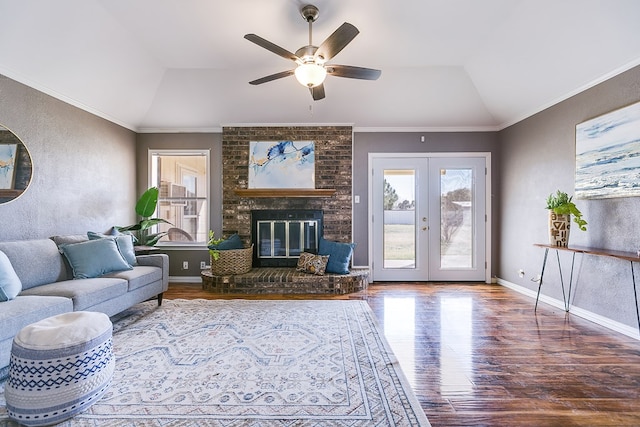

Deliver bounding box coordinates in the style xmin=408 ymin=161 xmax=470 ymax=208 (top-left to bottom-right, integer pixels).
xmin=498 ymin=67 xmax=640 ymax=327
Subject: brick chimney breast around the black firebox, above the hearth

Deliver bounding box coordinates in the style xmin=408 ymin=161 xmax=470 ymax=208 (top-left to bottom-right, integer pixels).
xmin=222 ymin=126 xmax=353 ymax=251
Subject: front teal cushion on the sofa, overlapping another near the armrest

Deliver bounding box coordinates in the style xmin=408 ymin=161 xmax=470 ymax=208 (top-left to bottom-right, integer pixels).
xmin=60 ymin=238 xmax=132 ymax=279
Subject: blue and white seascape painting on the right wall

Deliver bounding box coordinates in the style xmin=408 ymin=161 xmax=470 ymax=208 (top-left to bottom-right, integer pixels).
xmin=575 ymin=102 xmax=640 ymax=199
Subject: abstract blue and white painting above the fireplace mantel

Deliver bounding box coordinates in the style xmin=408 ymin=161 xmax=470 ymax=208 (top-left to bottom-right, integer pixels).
xmin=249 ymin=141 xmax=315 ymax=188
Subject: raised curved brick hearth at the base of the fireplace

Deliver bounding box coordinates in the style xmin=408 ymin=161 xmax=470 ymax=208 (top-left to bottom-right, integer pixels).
xmin=202 ymin=267 xmax=369 ymax=295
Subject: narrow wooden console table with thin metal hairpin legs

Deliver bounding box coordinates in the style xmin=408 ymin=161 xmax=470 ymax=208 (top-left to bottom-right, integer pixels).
xmin=534 ymin=243 xmax=640 ymax=330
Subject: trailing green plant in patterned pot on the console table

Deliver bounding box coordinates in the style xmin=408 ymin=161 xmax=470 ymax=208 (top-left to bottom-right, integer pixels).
xmin=547 ymin=190 xmax=587 ymax=247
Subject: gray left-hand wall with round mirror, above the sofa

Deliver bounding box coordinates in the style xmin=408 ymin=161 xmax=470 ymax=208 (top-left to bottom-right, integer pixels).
xmin=0 ymin=76 xmax=136 ymax=240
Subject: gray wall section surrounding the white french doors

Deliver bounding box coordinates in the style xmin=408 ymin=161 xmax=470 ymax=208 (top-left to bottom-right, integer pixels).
xmin=353 ymin=132 xmax=500 ymax=276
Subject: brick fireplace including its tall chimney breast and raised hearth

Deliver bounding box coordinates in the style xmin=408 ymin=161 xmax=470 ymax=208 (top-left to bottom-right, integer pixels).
xmin=208 ymin=126 xmax=369 ymax=294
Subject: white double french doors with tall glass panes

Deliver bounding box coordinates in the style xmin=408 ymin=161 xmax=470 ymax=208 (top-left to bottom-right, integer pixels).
xmin=369 ymin=153 xmax=490 ymax=282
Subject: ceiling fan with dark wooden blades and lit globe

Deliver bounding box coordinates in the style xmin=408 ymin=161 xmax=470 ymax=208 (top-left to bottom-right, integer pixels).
xmin=244 ymin=4 xmax=382 ymax=101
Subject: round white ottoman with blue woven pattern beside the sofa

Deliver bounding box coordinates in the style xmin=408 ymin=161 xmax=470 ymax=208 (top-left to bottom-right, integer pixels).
xmin=4 ymin=311 xmax=115 ymax=426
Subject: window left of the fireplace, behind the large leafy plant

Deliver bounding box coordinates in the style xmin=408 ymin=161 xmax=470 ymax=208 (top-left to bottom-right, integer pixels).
xmin=151 ymin=150 xmax=209 ymax=244
